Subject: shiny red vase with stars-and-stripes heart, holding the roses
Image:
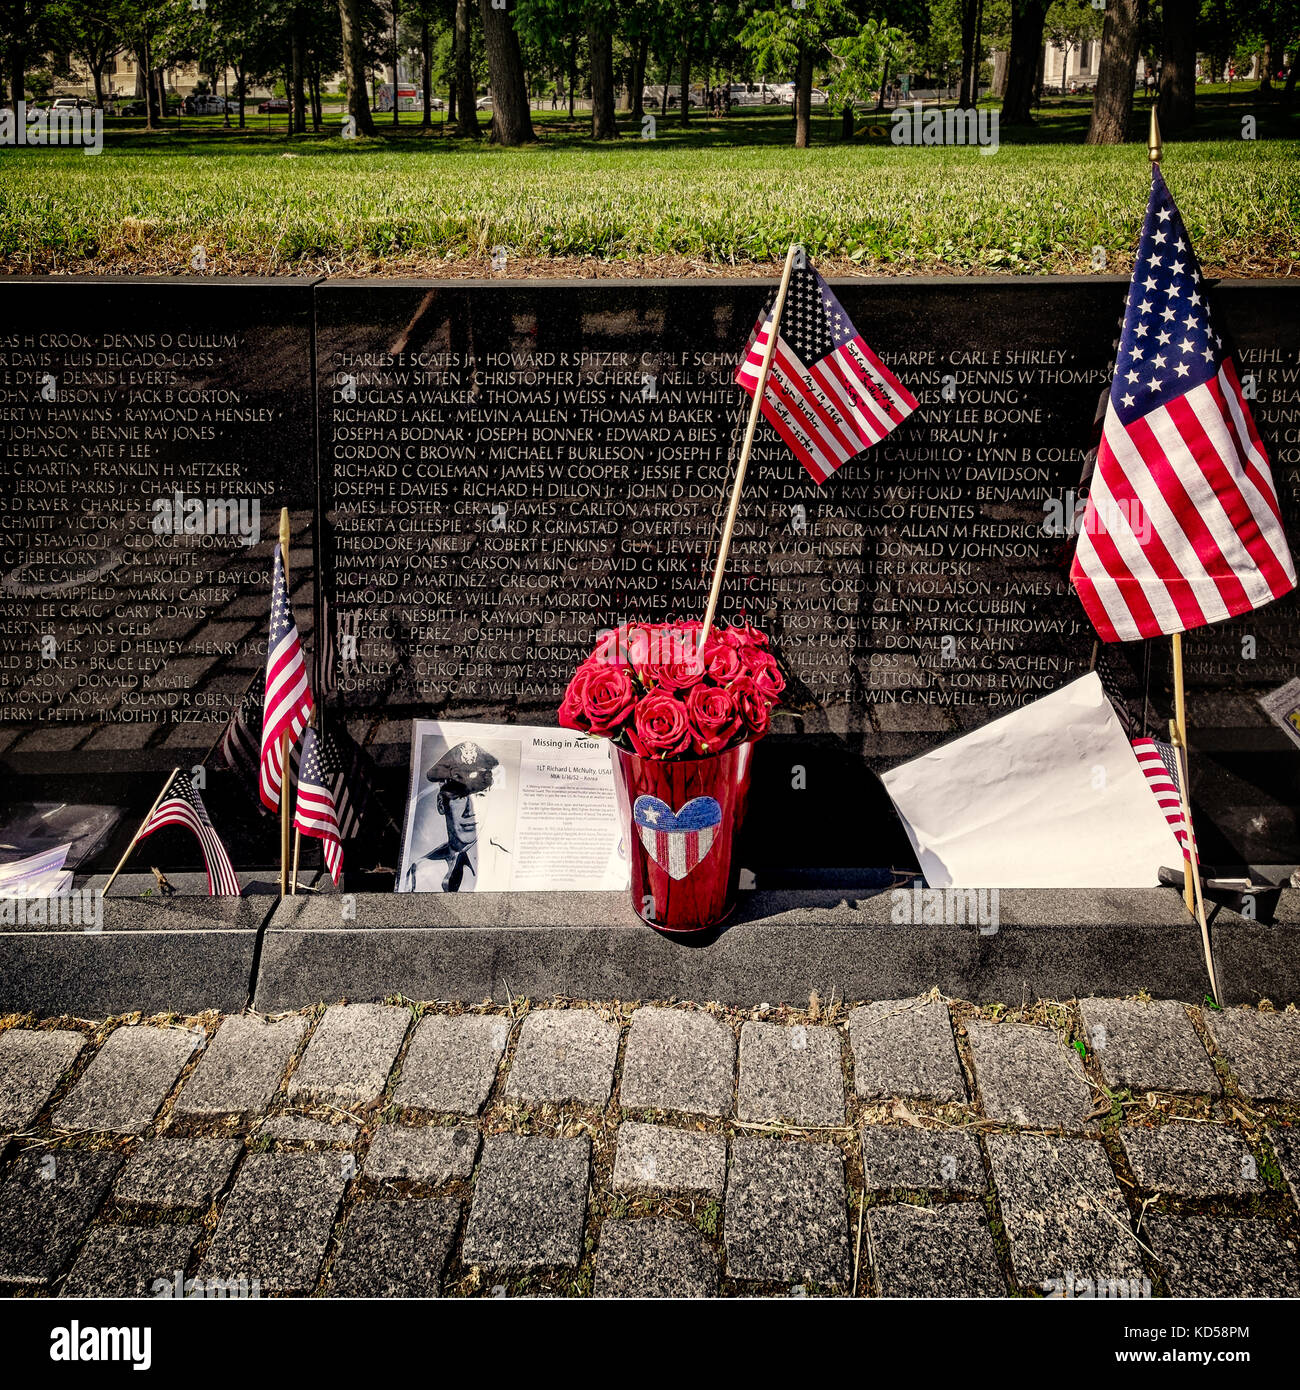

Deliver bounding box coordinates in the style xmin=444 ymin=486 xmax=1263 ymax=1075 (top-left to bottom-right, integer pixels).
xmin=610 ymin=744 xmax=754 ymax=931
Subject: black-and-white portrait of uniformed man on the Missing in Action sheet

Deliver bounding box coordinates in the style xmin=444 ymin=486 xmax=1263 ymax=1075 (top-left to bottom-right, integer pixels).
xmin=398 ymin=733 xmax=519 ymax=892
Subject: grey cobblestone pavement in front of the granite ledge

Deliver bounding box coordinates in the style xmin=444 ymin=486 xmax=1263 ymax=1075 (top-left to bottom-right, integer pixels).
xmin=0 ymin=994 xmax=1300 ymax=1297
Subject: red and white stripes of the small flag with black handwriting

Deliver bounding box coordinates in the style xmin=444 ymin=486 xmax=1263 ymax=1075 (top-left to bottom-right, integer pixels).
xmin=736 ymin=318 xmax=918 ymax=482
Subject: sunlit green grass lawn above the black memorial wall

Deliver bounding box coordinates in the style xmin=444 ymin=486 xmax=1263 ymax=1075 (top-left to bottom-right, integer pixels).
xmin=0 ymin=95 xmax=1300 ymax=275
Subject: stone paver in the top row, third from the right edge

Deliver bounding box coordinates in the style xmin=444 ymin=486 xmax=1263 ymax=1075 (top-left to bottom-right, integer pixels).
xmin=966 ymin=1019 xmax=1094 ymax=1130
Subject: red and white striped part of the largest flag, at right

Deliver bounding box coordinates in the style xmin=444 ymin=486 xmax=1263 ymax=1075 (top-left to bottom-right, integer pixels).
xmin=1071 ymin=359 xmax=1296 ymax=642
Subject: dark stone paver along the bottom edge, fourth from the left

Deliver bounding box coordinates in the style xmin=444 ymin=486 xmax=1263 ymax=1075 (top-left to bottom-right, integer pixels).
xmin=330 ymin=1198 xmax=460 ymax=1298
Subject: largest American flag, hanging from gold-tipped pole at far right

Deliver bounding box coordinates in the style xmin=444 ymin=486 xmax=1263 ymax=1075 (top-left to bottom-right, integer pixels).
xmin=1071 ymin=165 xmax=1296 ymax=642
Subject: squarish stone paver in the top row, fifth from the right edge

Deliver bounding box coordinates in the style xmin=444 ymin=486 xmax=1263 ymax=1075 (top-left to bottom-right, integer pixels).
xmin=736 ymin=1023 xmax=844 ymax=1127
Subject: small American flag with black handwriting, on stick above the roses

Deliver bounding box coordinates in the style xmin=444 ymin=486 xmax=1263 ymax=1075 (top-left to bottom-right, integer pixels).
xmin=736 ymin=261 xmax=916 ymax=482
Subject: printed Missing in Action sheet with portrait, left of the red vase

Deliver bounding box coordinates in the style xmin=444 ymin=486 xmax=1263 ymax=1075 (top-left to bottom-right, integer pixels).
xmin=396 ymin=720 xmax=628 ymax=892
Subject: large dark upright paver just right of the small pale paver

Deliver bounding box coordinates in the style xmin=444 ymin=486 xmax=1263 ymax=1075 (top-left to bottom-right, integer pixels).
xmin=723 ymin=1138 xmax=850 ymax=1286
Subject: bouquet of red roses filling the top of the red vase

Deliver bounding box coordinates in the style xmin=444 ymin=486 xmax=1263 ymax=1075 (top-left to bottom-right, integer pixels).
xmin=559 ymin=623 xmax=786 ymax=759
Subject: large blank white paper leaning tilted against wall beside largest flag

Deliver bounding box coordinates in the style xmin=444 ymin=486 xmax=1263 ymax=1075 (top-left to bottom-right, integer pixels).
xmin=881 ymin=671 xmax=1182 ymax=888
